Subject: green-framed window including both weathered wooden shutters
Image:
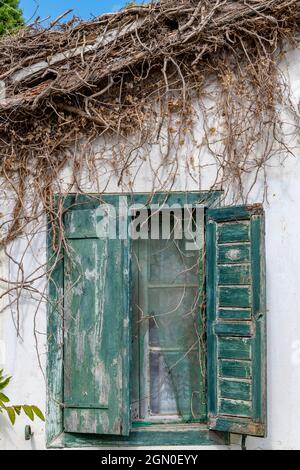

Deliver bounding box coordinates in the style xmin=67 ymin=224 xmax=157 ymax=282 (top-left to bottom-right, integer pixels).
xmin=47 ymin=193 xmax=266 ymax=447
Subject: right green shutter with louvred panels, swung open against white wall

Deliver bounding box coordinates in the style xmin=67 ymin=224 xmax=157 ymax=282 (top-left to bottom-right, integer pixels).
xmin=206 ymin=205 xmax=266 ymax=437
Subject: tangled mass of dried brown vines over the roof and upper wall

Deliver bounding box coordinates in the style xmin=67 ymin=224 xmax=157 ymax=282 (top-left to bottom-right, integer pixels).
xmin=0 ymin=0 xmax=300 ymax=342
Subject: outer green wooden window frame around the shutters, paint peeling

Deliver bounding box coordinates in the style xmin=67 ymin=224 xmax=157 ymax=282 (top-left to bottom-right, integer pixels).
xmin=46 ymin=191 xmax=229 ymax=448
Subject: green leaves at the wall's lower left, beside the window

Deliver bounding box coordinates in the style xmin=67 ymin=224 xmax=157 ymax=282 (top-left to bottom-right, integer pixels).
xmin=0 ymin=369 xmax=45 ymax=425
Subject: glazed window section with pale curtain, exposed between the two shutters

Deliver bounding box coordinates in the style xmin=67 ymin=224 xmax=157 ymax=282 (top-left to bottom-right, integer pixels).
xmin=132 ymin=209 xmax=205 ymax=422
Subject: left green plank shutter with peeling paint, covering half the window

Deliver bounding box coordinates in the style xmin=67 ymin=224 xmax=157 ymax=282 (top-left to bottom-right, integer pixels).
xmin=63 ymin=209 xmax=130 ymax=436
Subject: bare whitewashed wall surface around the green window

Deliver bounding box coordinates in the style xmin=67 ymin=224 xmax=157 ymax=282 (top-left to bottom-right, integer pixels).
xmin=0 ymin=51 xmax=300 ymax=449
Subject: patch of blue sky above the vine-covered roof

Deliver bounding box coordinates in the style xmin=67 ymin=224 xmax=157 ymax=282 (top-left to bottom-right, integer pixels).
xmin=20 ymin=0 xmax=143 ymax=22
